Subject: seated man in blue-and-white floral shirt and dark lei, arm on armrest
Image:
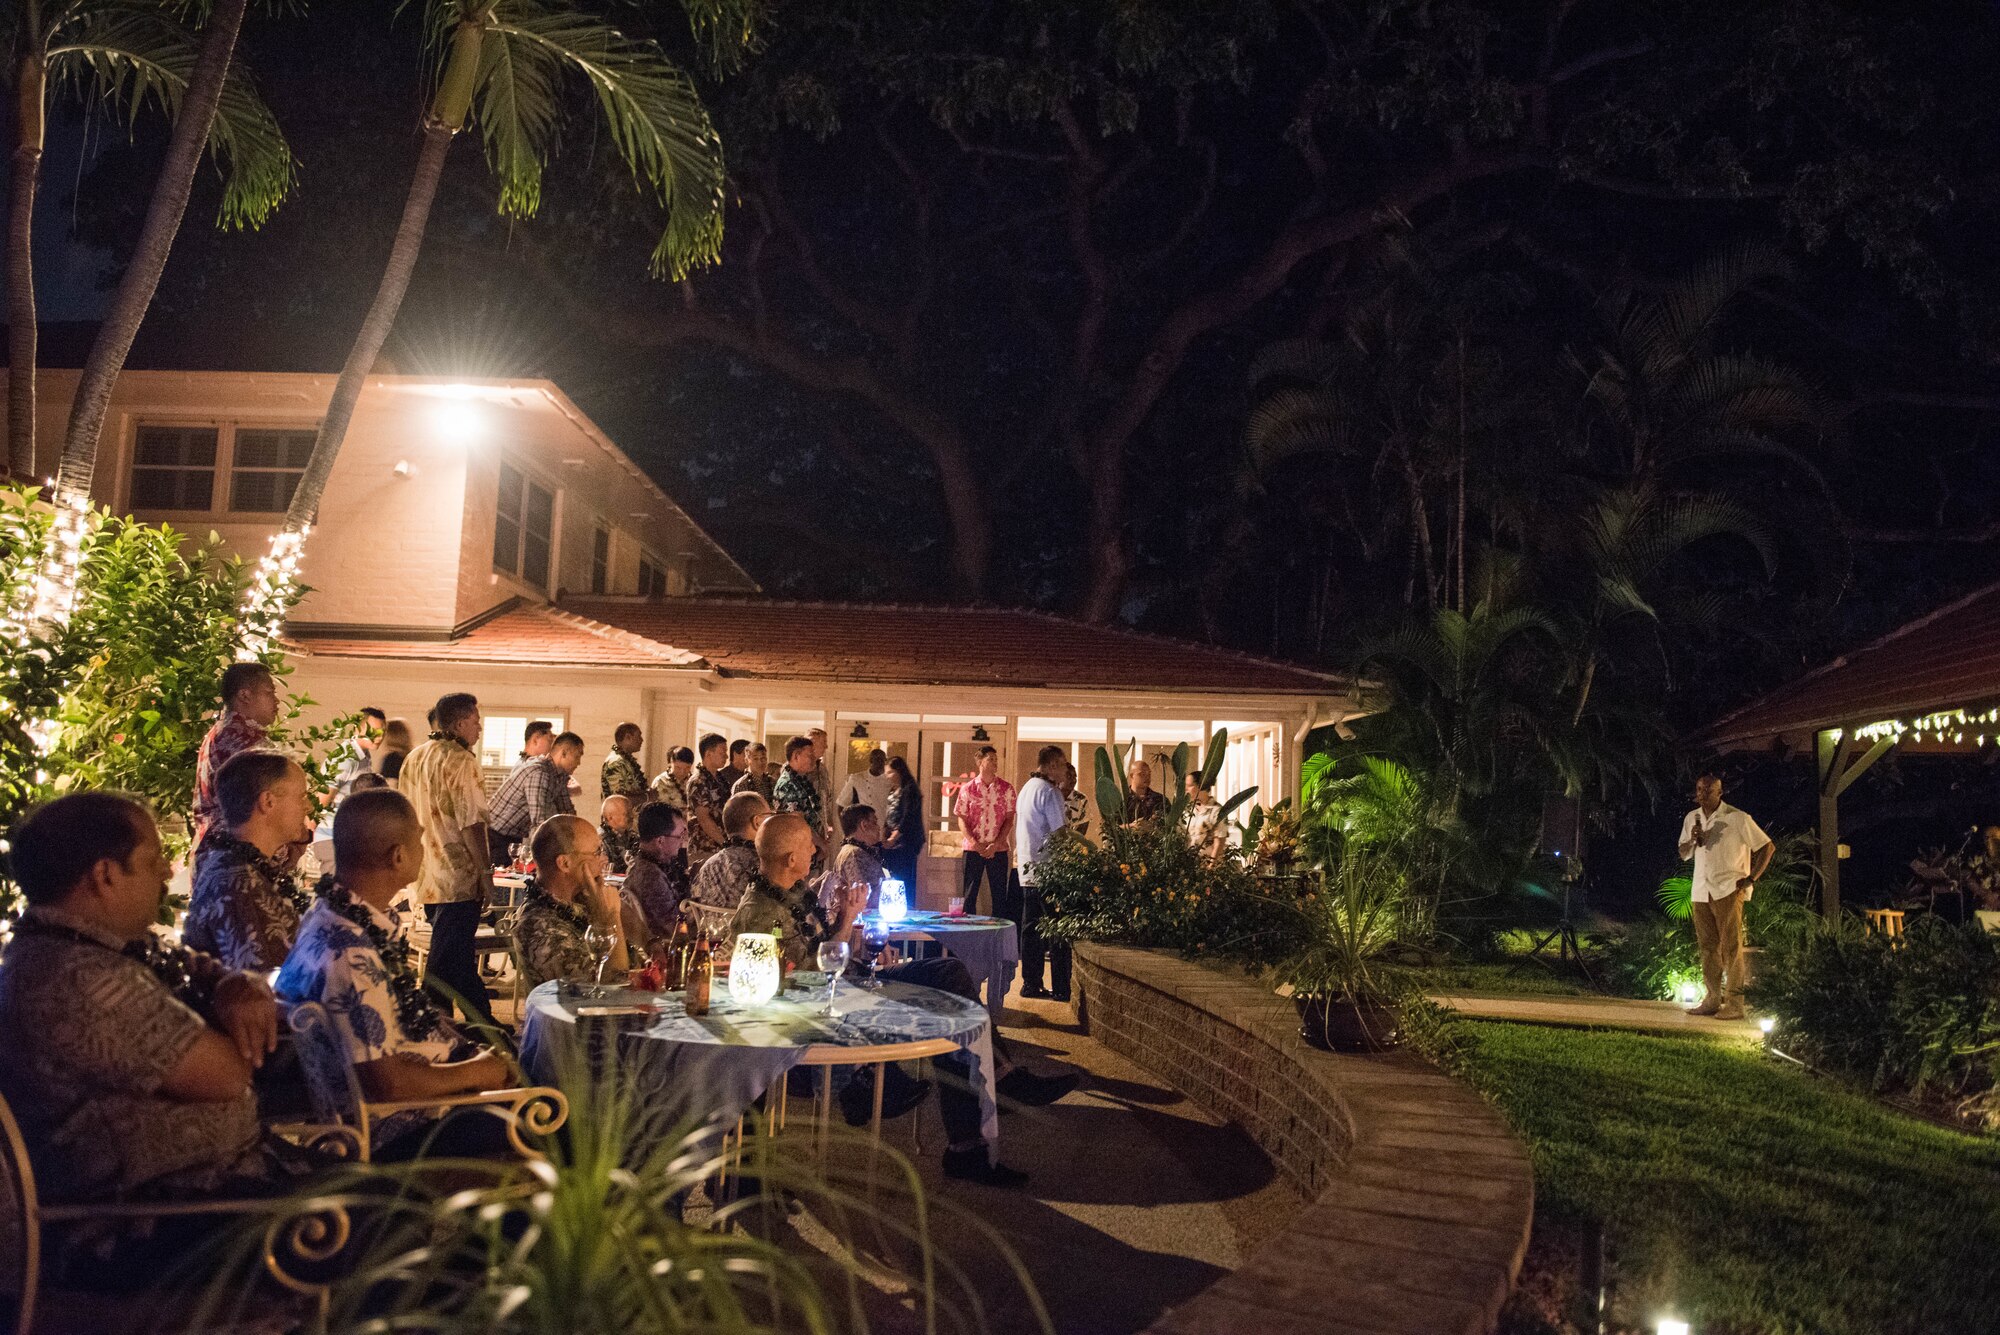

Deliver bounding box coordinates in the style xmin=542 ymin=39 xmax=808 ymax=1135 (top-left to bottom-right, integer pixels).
xmin=274 ymin=791 xmax=514 ymax=1161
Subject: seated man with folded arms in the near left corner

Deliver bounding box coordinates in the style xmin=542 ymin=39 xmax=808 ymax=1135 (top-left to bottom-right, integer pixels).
xmin=0 ymin=791 xmax=278 ymax=1201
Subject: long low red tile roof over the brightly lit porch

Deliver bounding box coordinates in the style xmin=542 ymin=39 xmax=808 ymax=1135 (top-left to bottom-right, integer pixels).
xmin=562 ymin=598 xmax=1348 ymax=695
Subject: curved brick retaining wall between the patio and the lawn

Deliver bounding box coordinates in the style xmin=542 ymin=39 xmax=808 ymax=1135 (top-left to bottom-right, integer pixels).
xmin=1076 ymin=945 xmax=1534 ymax=1335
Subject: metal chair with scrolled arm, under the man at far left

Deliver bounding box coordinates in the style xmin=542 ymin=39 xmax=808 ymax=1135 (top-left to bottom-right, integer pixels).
xmin=0 ymin=1097 xmax=366 ymax=1335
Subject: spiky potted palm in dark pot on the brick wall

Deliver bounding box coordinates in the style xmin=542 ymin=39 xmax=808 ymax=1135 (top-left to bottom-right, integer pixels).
xmin=1278 ymin=847 xmax=1408 ymax=1051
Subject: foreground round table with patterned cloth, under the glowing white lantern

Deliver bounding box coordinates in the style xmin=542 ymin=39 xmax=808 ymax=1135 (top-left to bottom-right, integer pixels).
xmin=520 ymin=975 xmax=1000 ymax=1145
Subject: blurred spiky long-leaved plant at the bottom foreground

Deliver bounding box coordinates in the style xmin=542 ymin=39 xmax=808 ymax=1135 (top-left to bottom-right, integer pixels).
xmin=192 ymin=1071 xmax=1052 ymax=1335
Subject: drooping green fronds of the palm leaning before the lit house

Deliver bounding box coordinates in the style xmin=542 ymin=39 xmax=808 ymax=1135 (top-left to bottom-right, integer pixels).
xmin=480 ymin=0 xmax=724 ymax=280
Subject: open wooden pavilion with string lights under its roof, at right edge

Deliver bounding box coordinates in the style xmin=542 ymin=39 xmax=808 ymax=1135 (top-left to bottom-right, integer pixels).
xmin=1696 ymin=584 xmax=2000 ymax=915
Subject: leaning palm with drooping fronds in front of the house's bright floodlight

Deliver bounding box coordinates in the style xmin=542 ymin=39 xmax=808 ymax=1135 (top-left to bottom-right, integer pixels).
xmin=276 ymin=0 xmax=728 ymax=544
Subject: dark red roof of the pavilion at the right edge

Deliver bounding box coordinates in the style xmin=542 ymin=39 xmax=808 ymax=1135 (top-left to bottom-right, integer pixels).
xmin=1700 ymin=584 xmax=2000 ymax=749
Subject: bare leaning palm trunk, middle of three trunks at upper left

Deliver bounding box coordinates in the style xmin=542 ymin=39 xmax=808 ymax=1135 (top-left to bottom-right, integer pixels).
xmin=56 ymin=0 xmax=250 ymax=496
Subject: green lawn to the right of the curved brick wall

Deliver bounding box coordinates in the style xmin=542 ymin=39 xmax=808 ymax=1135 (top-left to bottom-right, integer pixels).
xmin=1458 ymin=1023 xmax=2000 ymax=1335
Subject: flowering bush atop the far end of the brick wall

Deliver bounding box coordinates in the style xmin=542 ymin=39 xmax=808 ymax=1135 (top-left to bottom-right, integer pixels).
xmin=1040 ymin=823 xmax=1310 ymax=965
